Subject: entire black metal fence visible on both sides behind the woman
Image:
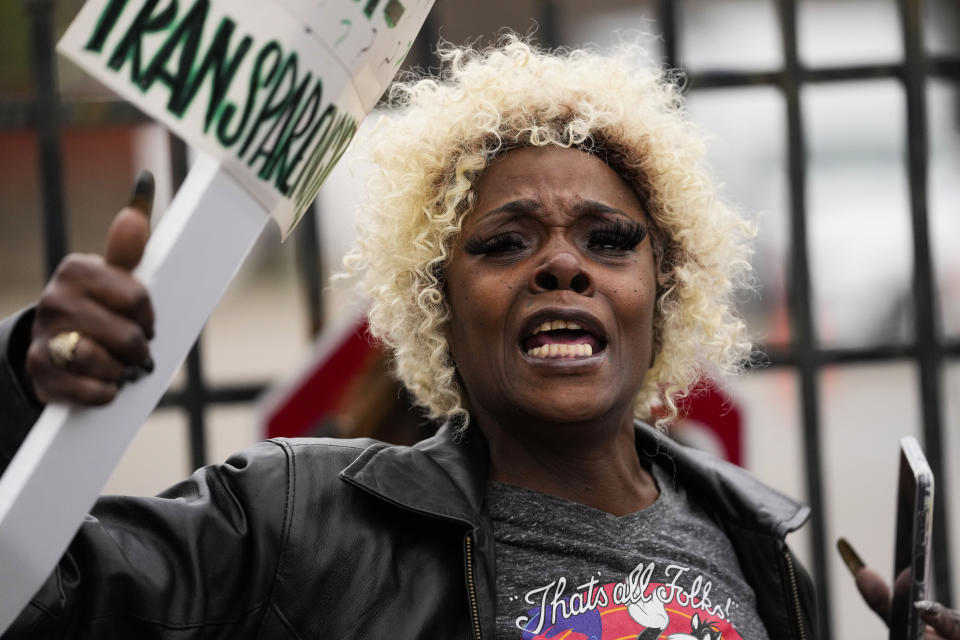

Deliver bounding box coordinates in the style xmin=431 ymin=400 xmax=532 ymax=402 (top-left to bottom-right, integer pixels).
xmin=9 ymin=0 xmax=960 ymax=638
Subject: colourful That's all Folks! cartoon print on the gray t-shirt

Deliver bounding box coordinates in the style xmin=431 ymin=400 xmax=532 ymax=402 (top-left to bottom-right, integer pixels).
xmin=516 ymin=562 xmax=742 ymax=640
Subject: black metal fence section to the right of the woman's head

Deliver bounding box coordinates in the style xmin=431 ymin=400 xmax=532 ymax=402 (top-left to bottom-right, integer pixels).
xmin=660 ymin=0 xmax=960 ymax=637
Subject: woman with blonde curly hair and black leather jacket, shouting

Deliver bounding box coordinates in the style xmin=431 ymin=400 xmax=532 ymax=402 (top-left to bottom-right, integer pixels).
xmin=0 ymin=37 xmax=952 ymax=640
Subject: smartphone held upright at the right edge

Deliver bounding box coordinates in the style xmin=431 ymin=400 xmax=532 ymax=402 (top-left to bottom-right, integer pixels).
xmin=890 ymin=436 xmax=933 ymax=640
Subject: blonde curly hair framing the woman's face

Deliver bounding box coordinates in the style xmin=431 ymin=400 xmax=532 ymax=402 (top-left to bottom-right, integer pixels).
xmin=346 ymin=35 xmax=754 ymax=426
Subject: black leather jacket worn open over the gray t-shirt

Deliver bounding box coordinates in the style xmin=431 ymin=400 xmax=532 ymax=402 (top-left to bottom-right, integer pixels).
xmin=0 ymin=308 xmax=816 ymax=640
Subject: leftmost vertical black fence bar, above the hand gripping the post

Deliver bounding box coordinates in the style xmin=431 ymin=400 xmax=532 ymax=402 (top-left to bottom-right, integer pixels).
xmin=24 ymin=0 xmax=67 ymax=278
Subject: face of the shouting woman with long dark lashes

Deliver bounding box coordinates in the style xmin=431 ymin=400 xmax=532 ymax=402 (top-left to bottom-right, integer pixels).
xmin=446 ymin=147 xmax=656 ymax=424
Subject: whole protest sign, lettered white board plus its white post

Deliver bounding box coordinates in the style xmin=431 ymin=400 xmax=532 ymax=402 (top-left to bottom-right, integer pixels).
xmin=0 ymin=0 xmax=433 ymax=634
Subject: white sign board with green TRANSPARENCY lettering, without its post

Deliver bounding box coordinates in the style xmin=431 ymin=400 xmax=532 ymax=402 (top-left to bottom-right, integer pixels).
xmin=58 ymin=0 xmax=433 ymax=237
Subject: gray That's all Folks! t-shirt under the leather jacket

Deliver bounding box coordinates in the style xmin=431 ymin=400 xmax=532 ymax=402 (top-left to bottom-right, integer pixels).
xmin=487 ymin=464 xmax=768 ymax=640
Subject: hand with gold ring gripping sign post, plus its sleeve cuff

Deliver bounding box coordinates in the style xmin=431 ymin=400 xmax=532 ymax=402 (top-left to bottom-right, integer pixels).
xmin=0 ymin=172 xmax=153 ymax=472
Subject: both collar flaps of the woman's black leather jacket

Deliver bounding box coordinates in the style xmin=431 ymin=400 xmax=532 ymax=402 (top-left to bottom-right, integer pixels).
xmin=340 ymin=421 xmax=810 ymax=538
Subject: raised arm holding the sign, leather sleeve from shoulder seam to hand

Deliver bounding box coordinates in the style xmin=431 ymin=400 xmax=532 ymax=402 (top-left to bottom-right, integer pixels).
xmin=0 ymin=174 xmax=290 ymax=640
